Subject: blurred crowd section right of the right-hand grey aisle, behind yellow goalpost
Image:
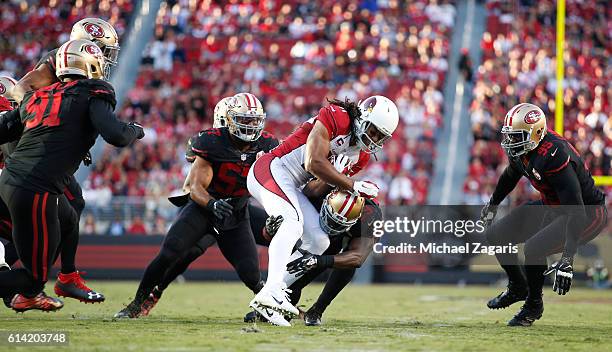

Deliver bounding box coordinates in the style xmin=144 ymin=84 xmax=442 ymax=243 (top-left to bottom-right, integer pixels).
xmin=464 ymin=0 xmax=612 ymax=204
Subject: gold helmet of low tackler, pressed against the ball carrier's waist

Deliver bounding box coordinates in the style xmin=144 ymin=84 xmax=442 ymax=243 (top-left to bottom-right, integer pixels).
xmin=319 ymin=190 xmax=365 ymax=236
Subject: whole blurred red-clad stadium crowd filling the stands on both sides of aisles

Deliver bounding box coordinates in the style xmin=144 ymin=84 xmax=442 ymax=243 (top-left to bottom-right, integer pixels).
xmin=0 ymin=0 xmax=612 ymax=235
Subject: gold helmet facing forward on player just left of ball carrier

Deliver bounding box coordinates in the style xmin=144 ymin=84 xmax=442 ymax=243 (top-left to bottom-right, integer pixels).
xmin=227 ymin=93 xmax=266 ymax=142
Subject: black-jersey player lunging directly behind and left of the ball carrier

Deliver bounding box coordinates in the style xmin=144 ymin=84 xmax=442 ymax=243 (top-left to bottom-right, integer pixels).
xmin=115 ymin=93 xmax=278 ymax=318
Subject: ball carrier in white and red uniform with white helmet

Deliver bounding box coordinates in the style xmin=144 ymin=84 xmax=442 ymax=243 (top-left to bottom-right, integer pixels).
xmin=247 ymin=95 xmax=399 ymax=316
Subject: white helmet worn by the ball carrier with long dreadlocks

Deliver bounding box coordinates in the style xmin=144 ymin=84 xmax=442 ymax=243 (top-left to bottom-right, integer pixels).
xmin=353 ymin=95 xmax=399 ymax=154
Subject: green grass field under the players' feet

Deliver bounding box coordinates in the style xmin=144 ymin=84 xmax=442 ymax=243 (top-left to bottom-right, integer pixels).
xmin=0 ymin=282 xmax=612 ymax=352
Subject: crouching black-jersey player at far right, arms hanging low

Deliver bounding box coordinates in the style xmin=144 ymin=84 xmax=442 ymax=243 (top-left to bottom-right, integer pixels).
xmin=481 ymin=103 xmax=607 ymax=326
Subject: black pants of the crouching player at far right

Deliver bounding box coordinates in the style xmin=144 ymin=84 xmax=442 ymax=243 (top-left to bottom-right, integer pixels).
xmin=486 ymin=201 xmax=608 ymax=300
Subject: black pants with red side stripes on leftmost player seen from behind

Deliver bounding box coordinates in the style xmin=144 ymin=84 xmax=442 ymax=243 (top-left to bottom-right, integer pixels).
xmin=0 ymin=184 xmax=78 ymax=297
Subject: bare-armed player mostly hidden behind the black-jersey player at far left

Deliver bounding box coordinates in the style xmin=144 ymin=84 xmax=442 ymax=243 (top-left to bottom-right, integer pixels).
xmin=2 ymin=18 xmax=120 ymax=303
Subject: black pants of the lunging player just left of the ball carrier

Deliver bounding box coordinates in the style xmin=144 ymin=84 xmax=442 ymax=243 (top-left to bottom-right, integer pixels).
xmin=135 ymin=200 xmax=262 ymax=302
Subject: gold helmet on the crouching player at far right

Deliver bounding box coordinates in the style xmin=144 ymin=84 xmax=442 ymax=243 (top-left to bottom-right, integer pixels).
xmin=501 ymin=103 xmax=547 ymax=158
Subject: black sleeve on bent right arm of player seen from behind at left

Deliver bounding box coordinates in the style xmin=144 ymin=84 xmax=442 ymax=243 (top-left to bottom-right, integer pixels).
xmin=89 ymin=98 xmax=138 ymax=147
